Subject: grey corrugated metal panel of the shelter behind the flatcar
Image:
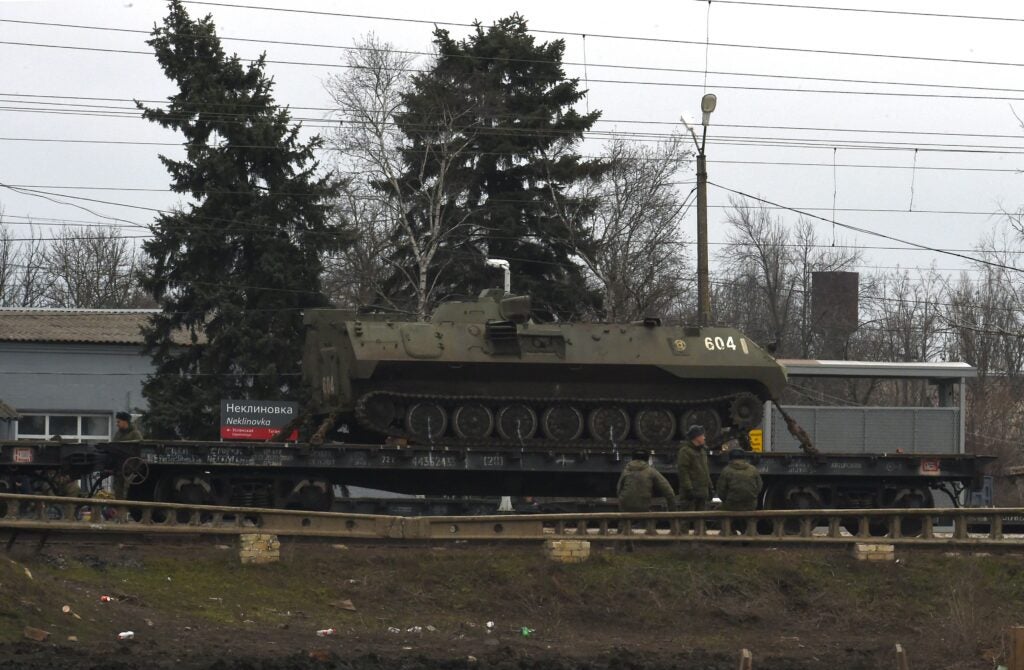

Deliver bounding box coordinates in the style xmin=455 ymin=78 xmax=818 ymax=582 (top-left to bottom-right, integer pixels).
xmin=770 ymin=407 xmax=959 ymax=454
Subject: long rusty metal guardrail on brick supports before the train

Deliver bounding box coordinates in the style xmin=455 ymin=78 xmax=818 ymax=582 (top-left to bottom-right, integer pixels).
xmin=0 ymin=494 xmax=1024 ymax=547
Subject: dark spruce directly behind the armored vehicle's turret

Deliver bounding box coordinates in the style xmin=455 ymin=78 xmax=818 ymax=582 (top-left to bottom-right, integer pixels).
xmin=396 ymin=14 xmax=607 ymax=317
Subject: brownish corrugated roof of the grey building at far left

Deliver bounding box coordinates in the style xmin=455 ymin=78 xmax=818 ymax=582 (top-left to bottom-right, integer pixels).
xmin=0 ymin=307 xmax=188 ymax=344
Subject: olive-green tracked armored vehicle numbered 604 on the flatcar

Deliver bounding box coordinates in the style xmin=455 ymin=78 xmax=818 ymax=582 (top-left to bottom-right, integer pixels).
xmin=303 ymin=290 xmax=786 ymax=448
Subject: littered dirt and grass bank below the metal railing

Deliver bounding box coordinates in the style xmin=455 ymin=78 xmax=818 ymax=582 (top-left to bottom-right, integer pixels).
xmin=0 ymin=541 xmax=1024 ymax=670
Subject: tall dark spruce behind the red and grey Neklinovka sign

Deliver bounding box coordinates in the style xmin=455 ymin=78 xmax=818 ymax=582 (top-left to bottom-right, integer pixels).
xmin=136 ymin=0 xmax=345 ymax=438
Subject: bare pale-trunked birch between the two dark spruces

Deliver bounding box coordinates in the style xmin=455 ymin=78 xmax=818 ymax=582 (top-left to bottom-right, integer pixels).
xmin=325 ymin=34 xmax=472 ymax=319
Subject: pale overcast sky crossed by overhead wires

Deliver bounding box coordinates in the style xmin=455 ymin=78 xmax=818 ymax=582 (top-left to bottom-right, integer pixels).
xmin=0 ymin=0 xmax=1024 ymax=288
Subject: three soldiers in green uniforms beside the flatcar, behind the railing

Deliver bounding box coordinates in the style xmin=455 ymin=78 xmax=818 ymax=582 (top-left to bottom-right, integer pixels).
xmin=616 ymin=425 xmax=763 ymax=512
